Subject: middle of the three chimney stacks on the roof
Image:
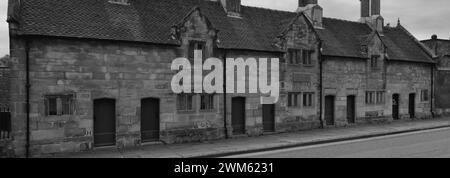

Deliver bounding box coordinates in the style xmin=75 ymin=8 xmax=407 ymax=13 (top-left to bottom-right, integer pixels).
xmin=297 ymin=0 xmax=323 ymax=28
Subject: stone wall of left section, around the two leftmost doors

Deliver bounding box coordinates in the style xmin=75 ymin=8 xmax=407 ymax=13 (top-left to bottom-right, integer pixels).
xmin=11 ymin=36 xmax=229 ymax=155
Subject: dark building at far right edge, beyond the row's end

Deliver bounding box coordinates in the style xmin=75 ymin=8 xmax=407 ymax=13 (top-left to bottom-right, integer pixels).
xmin=422 ymin=35 xmax=450 ymax=115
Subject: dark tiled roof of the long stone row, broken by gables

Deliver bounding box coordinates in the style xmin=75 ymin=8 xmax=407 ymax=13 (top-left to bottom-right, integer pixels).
xmin=12 ymin=0 xmax=431 ymax=62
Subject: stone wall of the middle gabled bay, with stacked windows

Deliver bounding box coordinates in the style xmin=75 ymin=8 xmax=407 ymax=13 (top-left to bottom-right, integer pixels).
xmin=279 ymin=16 xmax=321 ymax=131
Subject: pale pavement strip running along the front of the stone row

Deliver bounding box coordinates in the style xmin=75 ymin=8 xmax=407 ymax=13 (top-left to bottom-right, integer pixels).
xmin=52 ymin=118 xmax=450 ymax=158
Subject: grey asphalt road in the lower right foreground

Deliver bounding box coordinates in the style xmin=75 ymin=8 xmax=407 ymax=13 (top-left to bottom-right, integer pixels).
xmin=230 ymin=128 xmax=450 ymax=158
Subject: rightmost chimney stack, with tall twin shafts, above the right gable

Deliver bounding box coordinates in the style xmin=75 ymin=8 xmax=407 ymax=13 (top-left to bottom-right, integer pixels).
xmin=360 ymin=0 xmax=384 ymax=33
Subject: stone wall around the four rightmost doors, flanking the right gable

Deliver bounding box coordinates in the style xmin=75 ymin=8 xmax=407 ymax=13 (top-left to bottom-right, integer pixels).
xmin=324 ymin=58 xmax=431 ymax=126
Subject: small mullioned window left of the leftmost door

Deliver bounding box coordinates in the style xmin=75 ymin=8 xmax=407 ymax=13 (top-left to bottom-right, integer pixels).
xmin=45 ymin=95 xmax=74 ymax=116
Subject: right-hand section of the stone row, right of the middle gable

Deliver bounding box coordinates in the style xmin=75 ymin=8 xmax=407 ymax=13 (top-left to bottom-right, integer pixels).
xmin=317 ymin=0 xmax=434 ymax=126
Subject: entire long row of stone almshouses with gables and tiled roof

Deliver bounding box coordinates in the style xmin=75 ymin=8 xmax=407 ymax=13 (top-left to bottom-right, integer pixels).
xmin=8 ymin=0 xmax=434 ymax=156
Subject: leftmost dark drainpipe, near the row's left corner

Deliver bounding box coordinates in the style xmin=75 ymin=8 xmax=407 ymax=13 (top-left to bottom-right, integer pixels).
xmin=25 ymin=37 xmax=31 ymax=158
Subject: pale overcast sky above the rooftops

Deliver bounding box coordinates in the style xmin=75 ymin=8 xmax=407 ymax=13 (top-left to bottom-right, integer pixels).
xmin=0 ymin=0 xmax=450 ymax=57
